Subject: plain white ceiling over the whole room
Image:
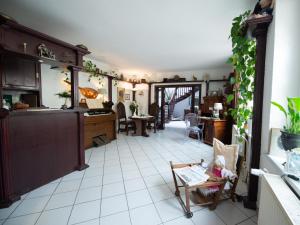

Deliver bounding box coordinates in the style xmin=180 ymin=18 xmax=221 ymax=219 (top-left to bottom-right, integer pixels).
xmin=0 ymin=0 xmax=256 ymax=72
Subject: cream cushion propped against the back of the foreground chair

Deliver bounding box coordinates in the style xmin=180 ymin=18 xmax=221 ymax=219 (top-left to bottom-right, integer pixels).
xmin=213 ymin=138 xmax=239 ymax=174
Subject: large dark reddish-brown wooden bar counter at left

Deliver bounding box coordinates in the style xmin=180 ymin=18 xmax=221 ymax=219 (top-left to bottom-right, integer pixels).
xmin=0 ymin=109 xmax=87 ymax=207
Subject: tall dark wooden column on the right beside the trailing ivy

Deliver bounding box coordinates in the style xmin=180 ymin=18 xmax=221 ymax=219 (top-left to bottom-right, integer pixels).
xmin=244 ymin=16 xmax=272 ymax=209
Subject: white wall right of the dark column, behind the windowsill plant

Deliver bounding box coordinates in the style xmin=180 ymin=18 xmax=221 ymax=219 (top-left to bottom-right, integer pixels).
xmin=261 ymin=0 xmax=300 ymax=171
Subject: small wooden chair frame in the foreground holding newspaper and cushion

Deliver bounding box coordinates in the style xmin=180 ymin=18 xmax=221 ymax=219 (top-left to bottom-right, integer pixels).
xmin=170 ymin=142 xmax=243 ymax=218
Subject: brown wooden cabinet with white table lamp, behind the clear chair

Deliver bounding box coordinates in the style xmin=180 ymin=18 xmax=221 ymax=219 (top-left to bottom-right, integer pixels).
xmin=201 ymin=118 xmax=231 ymax=145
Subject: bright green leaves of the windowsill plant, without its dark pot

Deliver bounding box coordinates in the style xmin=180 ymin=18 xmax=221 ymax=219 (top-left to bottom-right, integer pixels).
xmin=271 ymin=97 xmax=300 ymax=134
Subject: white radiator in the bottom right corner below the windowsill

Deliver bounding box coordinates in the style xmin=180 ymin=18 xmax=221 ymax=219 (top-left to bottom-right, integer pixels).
xmin=258 ymin=174 xmax=300 ymax=225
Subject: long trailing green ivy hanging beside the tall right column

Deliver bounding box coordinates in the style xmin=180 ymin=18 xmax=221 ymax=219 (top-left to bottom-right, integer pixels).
xmin=227 ymin=11 xmax=256 ymax=140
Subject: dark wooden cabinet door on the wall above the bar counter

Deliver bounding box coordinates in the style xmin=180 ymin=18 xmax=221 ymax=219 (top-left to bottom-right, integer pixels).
xmin=2 ymin=55 xmax=39 ymax=90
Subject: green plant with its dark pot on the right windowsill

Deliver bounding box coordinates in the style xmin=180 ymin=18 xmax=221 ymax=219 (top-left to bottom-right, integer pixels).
xmin=272 ymin=97 xmax=300 ymax=150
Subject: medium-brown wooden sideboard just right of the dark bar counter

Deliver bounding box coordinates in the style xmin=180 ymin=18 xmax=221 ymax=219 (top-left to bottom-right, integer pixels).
xmin=84 ymin=112 xmax=116 ymax=149
